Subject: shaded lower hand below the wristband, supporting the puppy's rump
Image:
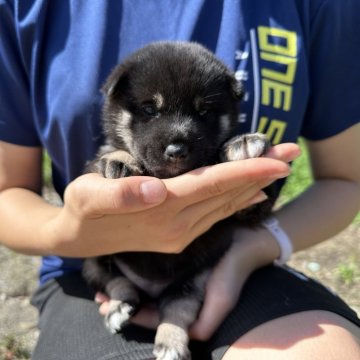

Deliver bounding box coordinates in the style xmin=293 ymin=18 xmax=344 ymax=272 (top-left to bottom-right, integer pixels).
xmin=189 ymin=227 xmax=280 ymax=341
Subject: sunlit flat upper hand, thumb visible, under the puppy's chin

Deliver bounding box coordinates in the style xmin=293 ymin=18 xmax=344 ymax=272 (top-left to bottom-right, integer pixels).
xmin=47 ymin=144 xmax=299 ymax=257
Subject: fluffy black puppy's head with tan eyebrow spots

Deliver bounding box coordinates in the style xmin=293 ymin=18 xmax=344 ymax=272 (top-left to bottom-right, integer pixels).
xmin=103 ymin=42 xmax=242 ymax=178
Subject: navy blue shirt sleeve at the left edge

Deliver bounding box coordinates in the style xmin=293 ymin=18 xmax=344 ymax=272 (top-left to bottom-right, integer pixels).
xmin=0 ymin=0 xmax=40 ymax=146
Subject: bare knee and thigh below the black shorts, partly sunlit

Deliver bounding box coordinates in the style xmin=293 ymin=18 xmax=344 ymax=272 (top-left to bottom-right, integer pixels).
xmin=223 ymin=311 xmax=360 ymax=360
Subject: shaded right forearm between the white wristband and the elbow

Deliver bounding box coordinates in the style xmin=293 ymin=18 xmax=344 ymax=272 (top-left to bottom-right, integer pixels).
xmin=276 ymin=179 xmax=360 ymax=251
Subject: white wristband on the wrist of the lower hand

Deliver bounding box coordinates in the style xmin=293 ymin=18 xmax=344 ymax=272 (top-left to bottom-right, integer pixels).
xmin=262 ymin=217 xmax=293 ymax=265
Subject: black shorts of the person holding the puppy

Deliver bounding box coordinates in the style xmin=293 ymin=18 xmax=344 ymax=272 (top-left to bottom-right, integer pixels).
xmin=32 ymin=266 xmax=360 ymax=360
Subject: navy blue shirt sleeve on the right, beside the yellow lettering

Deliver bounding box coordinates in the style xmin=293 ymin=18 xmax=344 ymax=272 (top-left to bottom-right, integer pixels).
xmin=302 ymin=0 xmax=360 ymax=140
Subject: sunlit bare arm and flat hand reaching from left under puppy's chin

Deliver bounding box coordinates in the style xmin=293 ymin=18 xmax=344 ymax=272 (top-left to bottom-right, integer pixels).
xmin=0 ymin=143 xmax=299 ymax=257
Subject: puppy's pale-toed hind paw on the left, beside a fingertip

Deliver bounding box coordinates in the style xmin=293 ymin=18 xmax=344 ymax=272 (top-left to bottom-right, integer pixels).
xmin=105 ymin=300 xmax=135 ymax=334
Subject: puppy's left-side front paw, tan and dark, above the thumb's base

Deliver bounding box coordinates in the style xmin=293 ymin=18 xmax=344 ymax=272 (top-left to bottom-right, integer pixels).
xmin=98 ymin=150 xmax=142 ymax=179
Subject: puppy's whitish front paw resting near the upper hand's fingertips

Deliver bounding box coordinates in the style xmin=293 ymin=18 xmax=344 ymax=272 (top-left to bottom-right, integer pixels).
xmin=221 ymin=133 xmax=270 ymax=161
